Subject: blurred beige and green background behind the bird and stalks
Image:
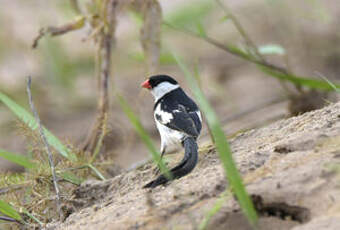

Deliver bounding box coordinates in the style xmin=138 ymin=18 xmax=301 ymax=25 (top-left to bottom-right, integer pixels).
xmin=0 ymin=0 xmax=340 ymax=171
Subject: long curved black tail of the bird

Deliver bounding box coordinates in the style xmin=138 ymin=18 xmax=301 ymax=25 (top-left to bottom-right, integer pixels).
xmin=143 ymin=137 xmax=198 ymax=188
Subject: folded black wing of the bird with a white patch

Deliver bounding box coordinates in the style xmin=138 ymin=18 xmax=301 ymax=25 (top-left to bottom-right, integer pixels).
xmin=155 ymin=104 xmax=200 ymax=137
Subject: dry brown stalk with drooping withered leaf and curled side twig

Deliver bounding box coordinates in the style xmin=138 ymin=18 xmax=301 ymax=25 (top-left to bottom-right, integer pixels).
xmin=32 ymin=0 xmax=162 ymax=153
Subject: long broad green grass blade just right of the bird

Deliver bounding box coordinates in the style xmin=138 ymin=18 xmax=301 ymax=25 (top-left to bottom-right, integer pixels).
xmin=174 ymin=55 xmax=257 ymax=228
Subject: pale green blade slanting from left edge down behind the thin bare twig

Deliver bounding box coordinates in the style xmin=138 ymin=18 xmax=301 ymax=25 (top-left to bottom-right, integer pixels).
xmin=0 ymin=92 xmax=77 ymax=161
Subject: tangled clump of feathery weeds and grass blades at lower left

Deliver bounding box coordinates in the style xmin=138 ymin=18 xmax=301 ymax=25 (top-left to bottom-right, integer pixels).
xmin=0 ymin=92 xmax=109 ymax=226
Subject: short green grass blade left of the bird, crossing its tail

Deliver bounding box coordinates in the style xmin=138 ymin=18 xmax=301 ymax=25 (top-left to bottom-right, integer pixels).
xmin=117 ymin=93 xmax=171 ymax=178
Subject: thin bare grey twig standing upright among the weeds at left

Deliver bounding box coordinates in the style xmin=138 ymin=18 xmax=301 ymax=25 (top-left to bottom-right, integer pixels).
xmin=27 ymin=76 xmax=63 ymax=220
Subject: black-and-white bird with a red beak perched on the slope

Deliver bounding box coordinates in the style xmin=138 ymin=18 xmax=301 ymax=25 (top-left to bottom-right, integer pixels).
xmin=141 ymin=74 xmax=202 ymax=188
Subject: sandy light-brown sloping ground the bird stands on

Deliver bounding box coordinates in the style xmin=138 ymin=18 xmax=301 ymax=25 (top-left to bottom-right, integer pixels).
xmin=50 ymin=103 xmax=340 ymax=230
